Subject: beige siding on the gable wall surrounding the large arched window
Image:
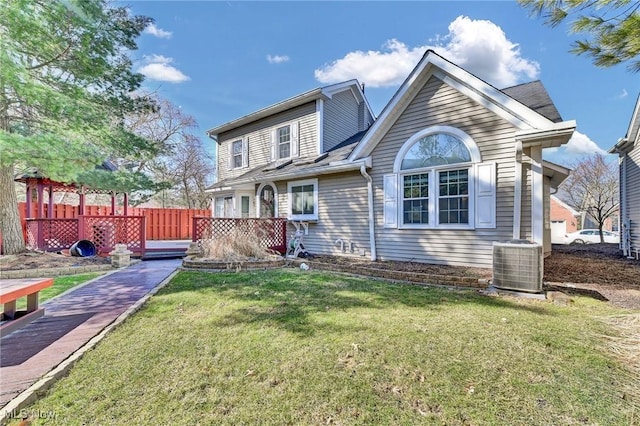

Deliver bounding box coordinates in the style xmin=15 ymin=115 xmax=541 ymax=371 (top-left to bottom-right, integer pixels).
xmin=370 ymin=77 xmax=515 ymax=267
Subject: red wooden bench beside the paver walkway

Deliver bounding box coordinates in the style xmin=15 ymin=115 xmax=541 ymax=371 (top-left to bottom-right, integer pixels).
xmin=0 ymin=278 xmax=53 ymax=337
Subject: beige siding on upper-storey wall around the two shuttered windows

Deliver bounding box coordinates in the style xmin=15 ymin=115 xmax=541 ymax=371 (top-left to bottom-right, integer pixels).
xmin=218 ymin=101 xmax=319 ymax=180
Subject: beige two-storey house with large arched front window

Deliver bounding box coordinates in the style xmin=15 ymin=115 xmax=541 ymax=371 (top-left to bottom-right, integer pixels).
xmin=208 ymin=50 xmax=575 ymax=267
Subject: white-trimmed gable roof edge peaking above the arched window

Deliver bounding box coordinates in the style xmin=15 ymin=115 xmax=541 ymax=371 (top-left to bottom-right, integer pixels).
xmin=349 ymin=50 xmax=576 ymax=160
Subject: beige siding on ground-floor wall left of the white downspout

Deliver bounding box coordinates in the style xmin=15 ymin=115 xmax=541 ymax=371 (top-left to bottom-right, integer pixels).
xmin=277 ymin=172 xmax=371 ymax=258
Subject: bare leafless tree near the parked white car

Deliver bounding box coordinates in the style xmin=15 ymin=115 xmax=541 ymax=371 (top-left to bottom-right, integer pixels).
xmin=561 ymin=154 xmax=619 ymax=243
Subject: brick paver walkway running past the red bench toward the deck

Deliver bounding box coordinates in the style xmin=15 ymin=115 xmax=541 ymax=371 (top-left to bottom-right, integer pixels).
xmin=0 ymin=259 xmax=182 ymax=407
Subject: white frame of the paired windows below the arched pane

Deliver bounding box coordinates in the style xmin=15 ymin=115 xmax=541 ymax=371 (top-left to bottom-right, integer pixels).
xmin=398 ymin=163 xmax=475 ymax=229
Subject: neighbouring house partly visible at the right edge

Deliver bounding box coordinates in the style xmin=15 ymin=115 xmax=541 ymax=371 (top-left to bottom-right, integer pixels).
xmin=609 ymin=95 xmax=640 ymax=259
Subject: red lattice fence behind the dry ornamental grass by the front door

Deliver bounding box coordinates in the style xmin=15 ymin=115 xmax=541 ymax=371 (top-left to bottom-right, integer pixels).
xmin=192 ymin=217 xmax=287 ymax=254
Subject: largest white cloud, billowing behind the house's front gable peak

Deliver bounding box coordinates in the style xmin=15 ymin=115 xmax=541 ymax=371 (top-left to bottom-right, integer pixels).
xmin=315 ymin=16 xmax=540 ymax=88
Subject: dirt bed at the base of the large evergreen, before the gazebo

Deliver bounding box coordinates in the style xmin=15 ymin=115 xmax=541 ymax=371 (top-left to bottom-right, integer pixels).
xmin=0 ymin=251 xmax=111 ymax=271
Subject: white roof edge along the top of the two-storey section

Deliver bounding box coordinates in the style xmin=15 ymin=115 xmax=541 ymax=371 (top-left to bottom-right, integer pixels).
xmin=207 ymin=79 xmax=375 ymax=138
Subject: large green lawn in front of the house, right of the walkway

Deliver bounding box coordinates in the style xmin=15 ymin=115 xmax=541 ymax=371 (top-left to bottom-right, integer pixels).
xmin=13 ymin=270 xmax=640 ymax=425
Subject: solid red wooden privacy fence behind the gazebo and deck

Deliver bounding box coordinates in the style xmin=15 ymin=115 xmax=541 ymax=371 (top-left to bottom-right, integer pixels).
xmin=18 ymin=202 xmax=211 ymax=240
